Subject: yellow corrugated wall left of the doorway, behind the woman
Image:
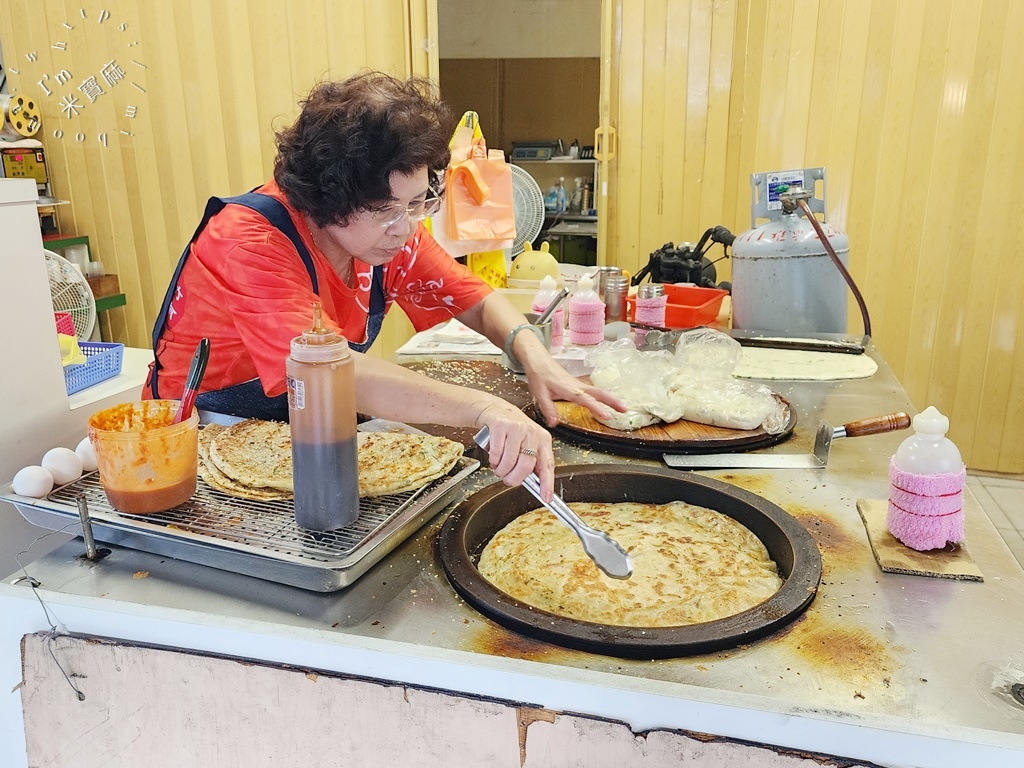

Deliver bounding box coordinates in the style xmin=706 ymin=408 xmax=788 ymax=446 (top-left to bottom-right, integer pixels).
xmin=0 ymin=0 xmax=428 ymax=360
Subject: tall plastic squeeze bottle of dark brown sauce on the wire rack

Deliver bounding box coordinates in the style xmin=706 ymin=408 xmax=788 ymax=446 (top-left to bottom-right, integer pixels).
xmin=285 ymin=301 xmax=359 ymax=530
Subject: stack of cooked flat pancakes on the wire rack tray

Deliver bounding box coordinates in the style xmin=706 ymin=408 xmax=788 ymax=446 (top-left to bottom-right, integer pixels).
xmin=199 ymin=419 xmax=463 ymax=501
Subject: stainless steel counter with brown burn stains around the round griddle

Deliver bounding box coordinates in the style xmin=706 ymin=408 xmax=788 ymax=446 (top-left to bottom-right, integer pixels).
xmin=6 ymin=349 xmax=1024 ymax=766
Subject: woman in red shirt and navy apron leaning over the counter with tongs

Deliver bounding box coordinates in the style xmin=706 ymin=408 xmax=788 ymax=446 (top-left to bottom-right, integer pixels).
xmin=145 ymin=73 xmax=624 ymax=499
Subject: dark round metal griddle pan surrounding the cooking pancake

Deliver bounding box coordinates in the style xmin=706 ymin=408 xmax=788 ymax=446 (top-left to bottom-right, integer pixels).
xmin=437 ymin=464 xmax=821 ymax=658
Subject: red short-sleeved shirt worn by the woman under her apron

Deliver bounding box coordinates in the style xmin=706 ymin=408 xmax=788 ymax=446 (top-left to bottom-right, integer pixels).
xmin=144 ymin=181 xmax=492 ymax=397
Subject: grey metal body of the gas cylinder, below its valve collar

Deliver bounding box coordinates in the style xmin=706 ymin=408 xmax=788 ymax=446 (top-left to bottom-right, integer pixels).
xmin=732 ymin=209 xmax=850 ymax=333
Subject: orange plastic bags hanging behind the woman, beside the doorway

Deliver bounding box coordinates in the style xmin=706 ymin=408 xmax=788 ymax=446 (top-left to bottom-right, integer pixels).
xmin=444 ymin=112 xmax=515 ymax=243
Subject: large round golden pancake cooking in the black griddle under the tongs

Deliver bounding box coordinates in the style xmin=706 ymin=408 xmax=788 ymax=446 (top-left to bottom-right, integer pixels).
xmin=479 ymin=502 xmax=782 ymax=627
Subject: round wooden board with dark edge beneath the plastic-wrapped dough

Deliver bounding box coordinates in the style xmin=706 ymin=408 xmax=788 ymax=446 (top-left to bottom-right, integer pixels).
xmin=552 ymin=395 xmax=797 ymax=458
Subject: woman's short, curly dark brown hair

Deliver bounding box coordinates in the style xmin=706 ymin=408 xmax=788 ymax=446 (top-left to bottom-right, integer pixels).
xmin=273 ymin=72 xmax=454 ymax=226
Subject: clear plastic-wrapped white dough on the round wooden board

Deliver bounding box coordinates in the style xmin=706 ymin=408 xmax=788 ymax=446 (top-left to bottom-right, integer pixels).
xmin=587 ymin=329 xmax=788 ymax=434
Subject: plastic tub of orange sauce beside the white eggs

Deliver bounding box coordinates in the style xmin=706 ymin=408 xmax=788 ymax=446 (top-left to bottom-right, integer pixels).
xmin=89 ymin=400 xmax=199 ymax=514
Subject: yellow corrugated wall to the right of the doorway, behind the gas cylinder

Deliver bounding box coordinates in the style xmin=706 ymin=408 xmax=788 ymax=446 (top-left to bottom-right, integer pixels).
xmin=600 ymin=0 xmax=1024 ymax=474
